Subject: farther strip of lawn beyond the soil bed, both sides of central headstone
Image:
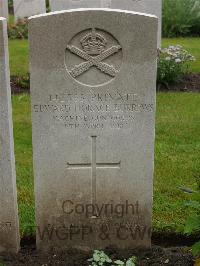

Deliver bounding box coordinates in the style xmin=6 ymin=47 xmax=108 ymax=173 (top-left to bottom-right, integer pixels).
xmin=9 ymin=38 xmax=200 ymax=76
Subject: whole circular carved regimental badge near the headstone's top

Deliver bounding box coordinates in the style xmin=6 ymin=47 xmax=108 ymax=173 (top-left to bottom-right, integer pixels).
xmin=66 ymin=28 xmax=122 ymax=86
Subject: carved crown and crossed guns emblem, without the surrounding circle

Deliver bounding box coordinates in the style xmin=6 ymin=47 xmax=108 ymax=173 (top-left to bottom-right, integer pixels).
xmin=67 ymin=29 xmax=121 ymax=78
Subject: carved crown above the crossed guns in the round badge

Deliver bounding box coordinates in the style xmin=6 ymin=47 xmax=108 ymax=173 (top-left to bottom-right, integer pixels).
xmin=81 ymin=28 xmax=107 ymax=55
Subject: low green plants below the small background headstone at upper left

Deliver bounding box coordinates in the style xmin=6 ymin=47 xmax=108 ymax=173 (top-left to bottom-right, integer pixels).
xmin=8 ymin=20 xmax=28 ymax=40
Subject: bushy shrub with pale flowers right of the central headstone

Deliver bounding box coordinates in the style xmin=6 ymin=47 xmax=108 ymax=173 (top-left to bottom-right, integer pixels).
xmin=157 ymin=45 xmax=195 ymax=85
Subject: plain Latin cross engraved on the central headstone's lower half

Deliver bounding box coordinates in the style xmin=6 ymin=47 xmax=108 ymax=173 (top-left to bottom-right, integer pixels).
xmin=67 ymin=136 xmax=121 ymax=204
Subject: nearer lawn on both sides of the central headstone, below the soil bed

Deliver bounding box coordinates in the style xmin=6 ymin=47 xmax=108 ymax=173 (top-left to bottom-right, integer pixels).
xmin=12 ymin=93 xmax=200 ymax=235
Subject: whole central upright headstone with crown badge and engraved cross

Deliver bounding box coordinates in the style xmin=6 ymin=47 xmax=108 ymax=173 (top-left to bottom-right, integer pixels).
xmin=29 ymin=9 xmax=157 ymax=249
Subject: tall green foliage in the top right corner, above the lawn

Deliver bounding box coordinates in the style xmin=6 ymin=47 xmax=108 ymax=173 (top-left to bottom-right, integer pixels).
xmin=162 ymin=0 xmax=200 ymax=38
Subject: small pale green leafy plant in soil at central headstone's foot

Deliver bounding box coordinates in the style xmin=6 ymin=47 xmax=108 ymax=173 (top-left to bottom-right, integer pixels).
xmin=88 ymin=250 xmax=137 ymax=266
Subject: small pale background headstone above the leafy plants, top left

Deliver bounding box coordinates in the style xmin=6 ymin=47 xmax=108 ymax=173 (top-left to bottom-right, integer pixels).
xmin=13 ymin=0 xmax=46 ymax=21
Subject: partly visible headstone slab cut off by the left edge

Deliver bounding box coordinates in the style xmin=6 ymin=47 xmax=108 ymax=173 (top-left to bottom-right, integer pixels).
xmin=0 ymin=18 xmax=19 ymax=252
